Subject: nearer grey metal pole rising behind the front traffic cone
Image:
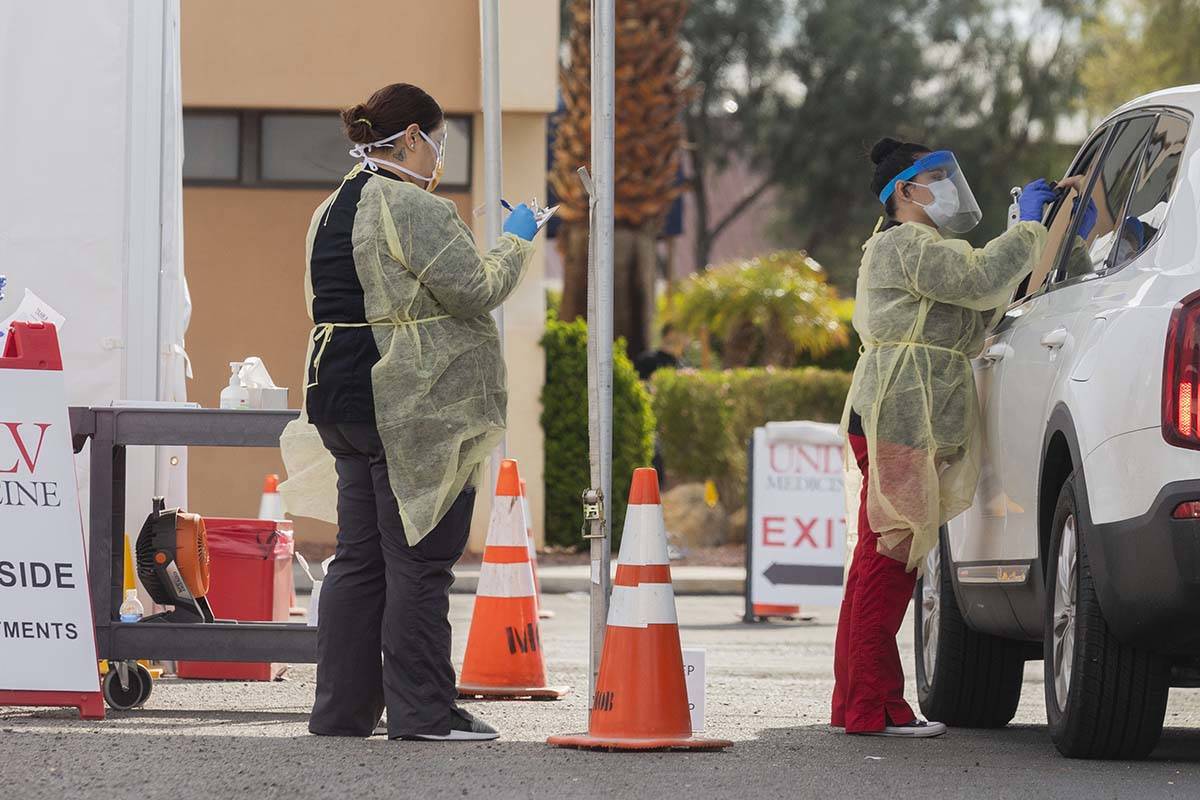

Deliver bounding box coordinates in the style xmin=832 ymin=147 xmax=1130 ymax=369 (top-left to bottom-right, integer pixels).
xmin=588 ymin=0 xmax=617 ymax=697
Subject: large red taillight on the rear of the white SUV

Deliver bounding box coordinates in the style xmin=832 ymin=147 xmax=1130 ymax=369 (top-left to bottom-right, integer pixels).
xmin=1163 ymin=291 xmax=1200 ymax=450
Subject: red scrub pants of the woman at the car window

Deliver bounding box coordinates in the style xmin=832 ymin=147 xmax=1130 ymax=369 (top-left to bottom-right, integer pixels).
xmin=832 ymin=434 xmax=917 ymax=733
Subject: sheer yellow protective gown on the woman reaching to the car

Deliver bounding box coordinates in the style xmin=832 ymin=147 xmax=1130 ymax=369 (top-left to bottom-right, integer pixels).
xmin=842 ymin=222 xmax=1046 ymax=570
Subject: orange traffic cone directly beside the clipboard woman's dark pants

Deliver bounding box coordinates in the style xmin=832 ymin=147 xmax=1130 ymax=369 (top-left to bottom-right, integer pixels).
xmin=458 ymin=458 xmax=570 ymax=699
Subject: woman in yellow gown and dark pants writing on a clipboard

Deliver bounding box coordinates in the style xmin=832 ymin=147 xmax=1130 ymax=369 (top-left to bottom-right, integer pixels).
xmin=280 ymin=84 xmax=538 ymax=740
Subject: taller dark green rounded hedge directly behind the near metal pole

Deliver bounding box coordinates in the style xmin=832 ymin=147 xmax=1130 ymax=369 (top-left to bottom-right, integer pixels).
xmin=541 ymin=319 xmax=654 ymax=547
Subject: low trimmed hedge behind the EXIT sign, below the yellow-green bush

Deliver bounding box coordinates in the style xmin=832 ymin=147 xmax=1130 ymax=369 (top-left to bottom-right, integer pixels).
xmin=653 ymin=367 xmax=851 ymax=510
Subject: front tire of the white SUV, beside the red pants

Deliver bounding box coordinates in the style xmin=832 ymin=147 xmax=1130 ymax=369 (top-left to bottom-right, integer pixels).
xmin=913 ymin=528 xmax=1027 ymax=728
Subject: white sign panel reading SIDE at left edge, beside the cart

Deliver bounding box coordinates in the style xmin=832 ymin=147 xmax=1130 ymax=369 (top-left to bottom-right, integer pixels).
xmin=0 ymin=368 xmax=100 ymax=690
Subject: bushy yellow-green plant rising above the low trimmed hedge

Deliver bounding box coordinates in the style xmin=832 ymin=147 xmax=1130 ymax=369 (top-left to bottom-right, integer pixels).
xmin=665 ymin=251 xmax=850 ymax=368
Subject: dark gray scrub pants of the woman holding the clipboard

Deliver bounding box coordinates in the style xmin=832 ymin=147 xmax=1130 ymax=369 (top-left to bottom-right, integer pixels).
xmin=308 ymin=423 xmax=475 ymax=738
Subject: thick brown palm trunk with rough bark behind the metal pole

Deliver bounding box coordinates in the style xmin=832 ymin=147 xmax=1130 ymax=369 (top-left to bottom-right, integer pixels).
xmin=550 ymin=0 xmax=691 ymax=355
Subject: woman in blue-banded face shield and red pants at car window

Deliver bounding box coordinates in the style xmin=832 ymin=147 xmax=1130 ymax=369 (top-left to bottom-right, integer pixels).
xmin=832 ymin=139 xmax=1080 ymax=736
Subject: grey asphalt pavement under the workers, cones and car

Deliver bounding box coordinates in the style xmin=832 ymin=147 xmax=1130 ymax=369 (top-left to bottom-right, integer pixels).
xmin=0 ymin=595 xmax=1200 ymax=800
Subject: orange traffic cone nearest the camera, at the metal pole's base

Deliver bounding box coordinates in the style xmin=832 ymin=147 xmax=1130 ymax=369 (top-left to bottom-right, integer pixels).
xmin=547 ymin=469 xmax=733 ymax=750
